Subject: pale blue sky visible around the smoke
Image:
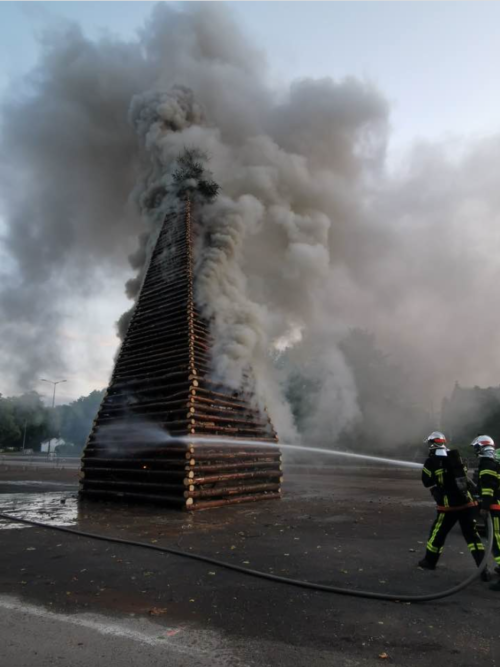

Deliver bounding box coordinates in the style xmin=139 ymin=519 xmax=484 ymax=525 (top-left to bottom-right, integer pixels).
xmin=0 ymin=2 xmax=500 ymax=402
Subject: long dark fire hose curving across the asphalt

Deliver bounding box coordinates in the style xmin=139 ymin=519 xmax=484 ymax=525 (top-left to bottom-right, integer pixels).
xmin=0 ymin=513 xmax=493 ymax=602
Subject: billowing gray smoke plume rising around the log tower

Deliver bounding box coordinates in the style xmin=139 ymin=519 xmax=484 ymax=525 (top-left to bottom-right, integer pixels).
xmin=0 ymin=3 xmax=500 ymax=444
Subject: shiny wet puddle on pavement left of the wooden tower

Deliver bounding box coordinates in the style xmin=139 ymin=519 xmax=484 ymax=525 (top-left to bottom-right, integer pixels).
xmin=0 ymin=493 xmax=78 ymax=530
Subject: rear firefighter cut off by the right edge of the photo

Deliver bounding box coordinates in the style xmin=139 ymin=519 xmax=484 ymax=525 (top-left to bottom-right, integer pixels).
xmin=471 ymin=435 xmax=500 ymax=591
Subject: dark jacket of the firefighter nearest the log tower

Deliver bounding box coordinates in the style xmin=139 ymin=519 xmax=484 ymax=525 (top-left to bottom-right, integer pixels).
xmin=422 ymin=450 xmax=477 ymax=512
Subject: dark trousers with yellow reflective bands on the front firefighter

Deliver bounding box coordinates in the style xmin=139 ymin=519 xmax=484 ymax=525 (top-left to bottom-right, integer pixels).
xmin=425 ymin=507 xmax=484 ymax=565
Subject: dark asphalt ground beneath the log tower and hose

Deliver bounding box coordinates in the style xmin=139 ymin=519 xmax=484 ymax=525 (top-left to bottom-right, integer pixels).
xmin=0 ymin=467 xmax=500 ymax=667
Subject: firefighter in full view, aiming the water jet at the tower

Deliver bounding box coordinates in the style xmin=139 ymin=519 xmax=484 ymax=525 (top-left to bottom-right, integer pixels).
xmin=418 ymin=431 xmax=491 ymax=581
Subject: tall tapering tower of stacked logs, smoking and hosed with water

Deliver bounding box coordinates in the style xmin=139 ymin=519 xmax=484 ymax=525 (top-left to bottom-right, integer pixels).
xmin=81 ymin=201 xmax=282 ymax=510
